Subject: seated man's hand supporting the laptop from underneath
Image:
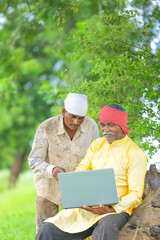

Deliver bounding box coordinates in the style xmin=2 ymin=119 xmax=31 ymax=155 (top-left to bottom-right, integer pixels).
xmin=83 ymin=204 xmax=115 ymax=215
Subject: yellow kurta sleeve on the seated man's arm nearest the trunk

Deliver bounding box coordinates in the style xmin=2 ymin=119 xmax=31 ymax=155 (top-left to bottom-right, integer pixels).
xmin=113 ymin=150 xmax=147 ymax=213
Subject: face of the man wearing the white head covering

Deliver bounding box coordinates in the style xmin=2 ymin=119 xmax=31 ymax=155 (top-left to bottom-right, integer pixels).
xmin=62 ymin=108 xmax=85 ymax=131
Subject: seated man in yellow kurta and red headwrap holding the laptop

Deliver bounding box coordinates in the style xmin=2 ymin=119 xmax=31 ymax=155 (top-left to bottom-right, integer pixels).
xmin=36 ymin=104 xmax=147 ymax=240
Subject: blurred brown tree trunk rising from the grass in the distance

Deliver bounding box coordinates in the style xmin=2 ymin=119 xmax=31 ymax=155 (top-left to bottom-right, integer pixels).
xmin=9 ymin=152 xmax=25 ymax=186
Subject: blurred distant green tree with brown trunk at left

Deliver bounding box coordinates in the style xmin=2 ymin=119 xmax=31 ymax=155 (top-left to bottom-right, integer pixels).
xmin=0 ymin=1 xmax=62 ymax=183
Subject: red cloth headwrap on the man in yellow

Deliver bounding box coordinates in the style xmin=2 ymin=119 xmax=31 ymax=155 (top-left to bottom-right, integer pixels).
xmin=99 ymin=106 xmax=130 ymax=134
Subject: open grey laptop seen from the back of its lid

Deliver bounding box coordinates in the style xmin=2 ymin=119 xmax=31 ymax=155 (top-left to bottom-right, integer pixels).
xmin=58 ymin=168 xmax=118 ymax=208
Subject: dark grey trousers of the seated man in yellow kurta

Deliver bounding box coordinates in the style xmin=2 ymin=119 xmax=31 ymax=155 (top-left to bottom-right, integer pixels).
xmin=35 ymin=213 xmax=130 ymax=240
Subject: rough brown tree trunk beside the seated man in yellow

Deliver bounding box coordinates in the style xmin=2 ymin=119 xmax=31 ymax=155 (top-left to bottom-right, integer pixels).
xmin=118 ymin=164 xmax=160 ymax=240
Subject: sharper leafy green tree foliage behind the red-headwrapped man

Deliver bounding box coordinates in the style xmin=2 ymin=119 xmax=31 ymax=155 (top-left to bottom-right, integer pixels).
xmin=64 ymin=11 xmax=160 ymax=155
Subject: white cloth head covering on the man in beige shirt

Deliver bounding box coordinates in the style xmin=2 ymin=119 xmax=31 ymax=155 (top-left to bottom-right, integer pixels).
xmin=64 ymin=93 xmax=88 ymax=116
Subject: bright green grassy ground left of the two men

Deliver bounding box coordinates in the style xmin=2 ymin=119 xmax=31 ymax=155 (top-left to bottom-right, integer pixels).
xmin=0 ymin=170 xmax=36 ymax=240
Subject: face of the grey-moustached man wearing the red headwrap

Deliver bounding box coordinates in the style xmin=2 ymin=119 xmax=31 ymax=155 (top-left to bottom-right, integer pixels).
xmin=100 ymin=122 xmax=125 ymax=143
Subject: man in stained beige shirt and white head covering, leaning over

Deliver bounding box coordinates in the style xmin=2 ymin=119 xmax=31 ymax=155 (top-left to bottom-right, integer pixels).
xmin=29 ymin=93 xmax=99 ymax=231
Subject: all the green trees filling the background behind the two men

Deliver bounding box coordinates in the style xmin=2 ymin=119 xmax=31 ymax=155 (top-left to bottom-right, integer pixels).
xmin=0 ymin=0 xmax=160 ymax=183
